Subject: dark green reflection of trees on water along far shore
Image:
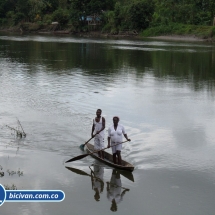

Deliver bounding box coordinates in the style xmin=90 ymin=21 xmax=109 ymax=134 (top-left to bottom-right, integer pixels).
xmin=0 ymin=34 xmax=215 ymax=90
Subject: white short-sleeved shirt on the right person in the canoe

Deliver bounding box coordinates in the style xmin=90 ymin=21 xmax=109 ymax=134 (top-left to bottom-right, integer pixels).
xmin=108 ymin=124 xmax=126 ymax=143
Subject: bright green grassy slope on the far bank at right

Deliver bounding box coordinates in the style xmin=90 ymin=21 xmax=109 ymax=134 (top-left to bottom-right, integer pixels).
xmin=140 ymin=23 xmax=215 ymax=39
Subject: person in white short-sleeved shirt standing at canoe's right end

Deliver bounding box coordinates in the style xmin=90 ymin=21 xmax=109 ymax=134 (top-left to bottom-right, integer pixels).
xmin=108 ymin=116 xmax=131 ymax=165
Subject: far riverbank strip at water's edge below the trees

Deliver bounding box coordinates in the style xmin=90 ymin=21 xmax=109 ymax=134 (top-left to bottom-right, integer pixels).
xmin=0 ymin=23 xmax=215 ymax=42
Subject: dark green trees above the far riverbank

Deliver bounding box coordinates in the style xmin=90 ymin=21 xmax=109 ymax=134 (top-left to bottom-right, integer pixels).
xmin=0 ymin=0 xmax=215 ymax=33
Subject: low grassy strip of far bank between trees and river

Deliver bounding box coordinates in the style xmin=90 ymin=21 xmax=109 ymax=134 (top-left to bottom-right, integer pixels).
xmin=0 ymin=23 xmax=215 ymax=41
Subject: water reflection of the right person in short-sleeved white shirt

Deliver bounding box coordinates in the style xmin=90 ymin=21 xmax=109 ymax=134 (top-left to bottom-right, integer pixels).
xmin=107 ymin=169 xmax=129 ymax=211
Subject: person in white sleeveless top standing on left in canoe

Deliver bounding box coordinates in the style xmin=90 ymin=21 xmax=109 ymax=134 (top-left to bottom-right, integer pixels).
xmin=91 ymin=109 xmax=105 ymax=159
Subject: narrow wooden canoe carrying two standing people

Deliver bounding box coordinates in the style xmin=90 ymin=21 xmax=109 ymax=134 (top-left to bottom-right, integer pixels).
xmin=86 ymin=143 xmax=134 ymax=172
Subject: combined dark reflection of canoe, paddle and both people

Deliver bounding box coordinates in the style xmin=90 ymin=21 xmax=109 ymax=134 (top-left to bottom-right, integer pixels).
xmin=66 ymin=164 xmax=134 ymax=211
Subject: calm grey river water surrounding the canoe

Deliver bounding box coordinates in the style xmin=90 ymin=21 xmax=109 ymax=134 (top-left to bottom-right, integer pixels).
xmin=0 ymin=33 xmax=215 ymax=215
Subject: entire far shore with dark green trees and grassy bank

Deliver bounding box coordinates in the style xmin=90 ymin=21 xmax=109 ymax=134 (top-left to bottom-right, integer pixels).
xmin=0 ymin=0 xmax=215 ymax=41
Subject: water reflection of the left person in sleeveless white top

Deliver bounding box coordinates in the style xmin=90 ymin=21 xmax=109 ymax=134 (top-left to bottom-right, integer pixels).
xmin=91 ymin=165 xmax=104 ymax=201
